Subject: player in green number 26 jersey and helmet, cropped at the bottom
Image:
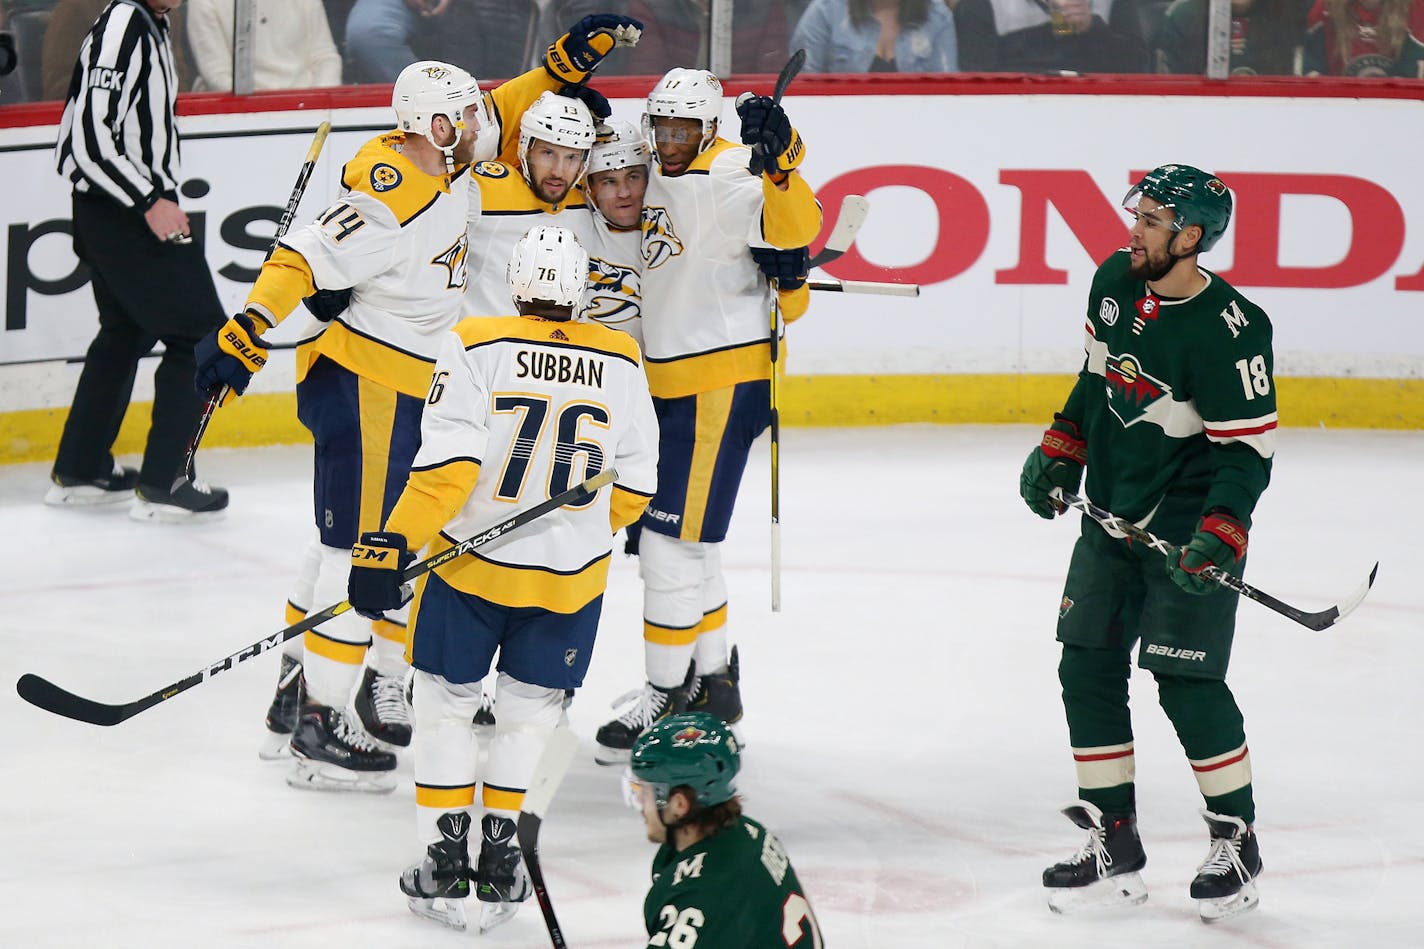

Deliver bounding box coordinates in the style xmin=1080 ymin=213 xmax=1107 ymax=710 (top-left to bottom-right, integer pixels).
xmin=628 ymin=712 xmax=823 ymax=949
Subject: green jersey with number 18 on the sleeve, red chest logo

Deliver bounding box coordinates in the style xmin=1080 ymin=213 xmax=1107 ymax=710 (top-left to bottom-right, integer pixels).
xmin=1064 ymin=251 xmax=1276 ymax=534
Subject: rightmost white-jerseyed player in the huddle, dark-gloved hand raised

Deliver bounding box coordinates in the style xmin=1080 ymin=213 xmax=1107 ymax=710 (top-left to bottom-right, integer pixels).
xmin=595 ymin=68 xmax=820 ymax=764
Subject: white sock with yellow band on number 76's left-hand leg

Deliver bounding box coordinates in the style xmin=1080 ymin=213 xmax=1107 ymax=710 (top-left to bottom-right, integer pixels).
xmin=410 ymin=671 xmax=480 ymax=844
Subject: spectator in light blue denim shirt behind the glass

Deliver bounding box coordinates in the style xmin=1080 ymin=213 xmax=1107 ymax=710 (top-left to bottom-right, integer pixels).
xmin=790 ymin=0 xmax=960 ymax=73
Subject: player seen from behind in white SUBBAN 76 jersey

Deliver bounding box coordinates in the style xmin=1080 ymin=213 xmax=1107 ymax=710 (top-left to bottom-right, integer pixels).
xmin=347 ymin=225 xmax=658 ymax=929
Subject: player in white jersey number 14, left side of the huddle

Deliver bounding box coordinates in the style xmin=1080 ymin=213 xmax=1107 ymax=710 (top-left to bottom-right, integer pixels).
xmin=197 ymin=53 xmax=586 ymax=791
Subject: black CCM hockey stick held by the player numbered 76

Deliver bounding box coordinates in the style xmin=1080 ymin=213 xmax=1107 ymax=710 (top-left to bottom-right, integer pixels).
xmin=14 ymin=467 xmax=618 ymax=725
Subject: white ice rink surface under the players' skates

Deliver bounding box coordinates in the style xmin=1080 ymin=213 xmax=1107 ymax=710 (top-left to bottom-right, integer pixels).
xmin=0 ymin=426 xmax=1424 ymax=949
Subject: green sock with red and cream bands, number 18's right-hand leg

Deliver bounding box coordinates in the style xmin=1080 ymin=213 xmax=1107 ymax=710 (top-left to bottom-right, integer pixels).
xmin=1156 ymin=674 xmax=1256 ymax=825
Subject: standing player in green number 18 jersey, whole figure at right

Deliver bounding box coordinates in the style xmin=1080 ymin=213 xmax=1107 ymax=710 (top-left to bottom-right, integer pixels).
xmin=1020 ymin=165 xmax=1276 ymax=922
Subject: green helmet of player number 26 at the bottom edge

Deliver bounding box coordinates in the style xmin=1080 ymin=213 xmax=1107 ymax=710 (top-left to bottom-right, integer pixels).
xmin=628 ymin=712 xmax=742 ymax=811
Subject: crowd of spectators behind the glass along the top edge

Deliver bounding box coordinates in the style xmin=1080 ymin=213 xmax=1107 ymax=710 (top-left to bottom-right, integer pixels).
xmin=0 ymin=0 xmax=1424 ymax=105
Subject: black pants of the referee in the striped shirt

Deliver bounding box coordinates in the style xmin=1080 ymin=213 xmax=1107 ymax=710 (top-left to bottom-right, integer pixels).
xmin=54 ymin=192 xmax=226 ymax=492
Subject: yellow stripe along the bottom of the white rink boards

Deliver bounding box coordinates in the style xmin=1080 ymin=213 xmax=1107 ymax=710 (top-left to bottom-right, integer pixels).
xmin=0 ymin=376 xmax=1424 ymax=465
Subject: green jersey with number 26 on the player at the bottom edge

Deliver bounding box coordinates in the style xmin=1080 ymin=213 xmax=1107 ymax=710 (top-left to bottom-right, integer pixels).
xmin=642 ymin=816 xmax=823 ymax=949
